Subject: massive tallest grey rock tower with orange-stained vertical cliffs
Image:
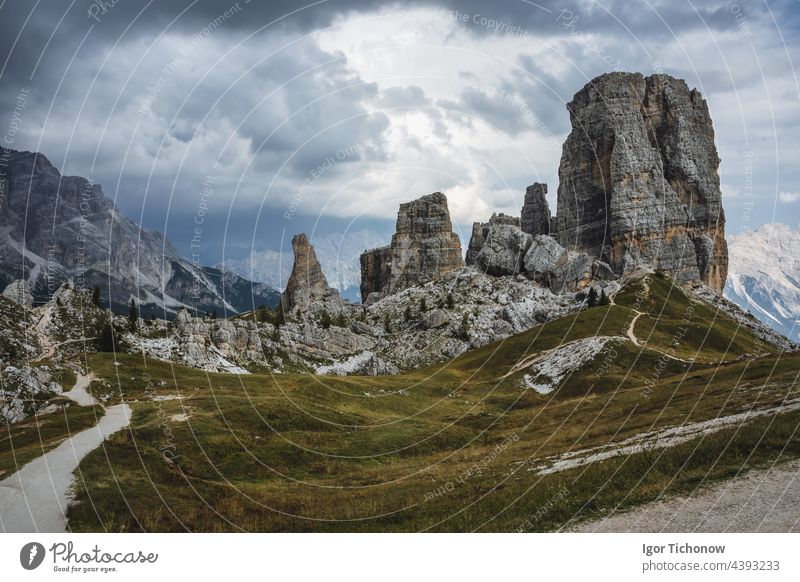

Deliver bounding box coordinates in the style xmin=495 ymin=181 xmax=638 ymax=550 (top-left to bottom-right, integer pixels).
xmin=555 ymin=73 xmax=728 ymax=293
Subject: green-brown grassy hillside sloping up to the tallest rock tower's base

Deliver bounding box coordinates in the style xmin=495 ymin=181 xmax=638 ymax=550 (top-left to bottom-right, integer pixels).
xmin=48 ymin=275 xmax=800 ymax=531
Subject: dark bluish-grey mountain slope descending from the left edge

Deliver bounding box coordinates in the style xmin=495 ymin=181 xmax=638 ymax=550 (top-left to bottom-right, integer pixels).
xmin=0 ymin=148 xmax=279 ymax=316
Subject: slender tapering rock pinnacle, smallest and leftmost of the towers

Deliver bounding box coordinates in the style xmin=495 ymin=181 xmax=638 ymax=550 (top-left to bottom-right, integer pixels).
xmin=281 ymin=233 xmax=339 ymax=312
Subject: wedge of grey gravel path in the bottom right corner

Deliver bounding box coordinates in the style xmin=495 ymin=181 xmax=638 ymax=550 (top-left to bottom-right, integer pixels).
xmin=566 ymin=461 xmax=800 ymax=533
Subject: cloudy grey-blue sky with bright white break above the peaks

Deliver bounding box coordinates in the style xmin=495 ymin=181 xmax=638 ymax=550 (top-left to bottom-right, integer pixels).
xmin=0 ymin=0 xmax=800 ymax=270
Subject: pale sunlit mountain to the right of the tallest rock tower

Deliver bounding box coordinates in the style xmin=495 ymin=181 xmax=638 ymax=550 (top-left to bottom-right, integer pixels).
xmin=725 ymin=224 xmax=800 ymax=341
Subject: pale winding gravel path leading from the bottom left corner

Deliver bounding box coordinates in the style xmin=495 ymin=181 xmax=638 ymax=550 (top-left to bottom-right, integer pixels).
xmin=0 ymin=375 xmax=131 ymax=533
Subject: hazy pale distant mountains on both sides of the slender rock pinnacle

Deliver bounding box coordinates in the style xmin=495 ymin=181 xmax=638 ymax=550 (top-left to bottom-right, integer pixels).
xmin=219 ymin=229 xmax=387 ymax=299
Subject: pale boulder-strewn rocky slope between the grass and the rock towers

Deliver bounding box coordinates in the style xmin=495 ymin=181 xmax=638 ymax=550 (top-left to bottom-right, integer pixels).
xmin=125 ymin=267 xmax=616 ymax=375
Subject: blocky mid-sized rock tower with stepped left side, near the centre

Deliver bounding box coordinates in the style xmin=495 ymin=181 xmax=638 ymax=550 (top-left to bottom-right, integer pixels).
xmin=361 ymin=192 xmax=464 ymax=301
